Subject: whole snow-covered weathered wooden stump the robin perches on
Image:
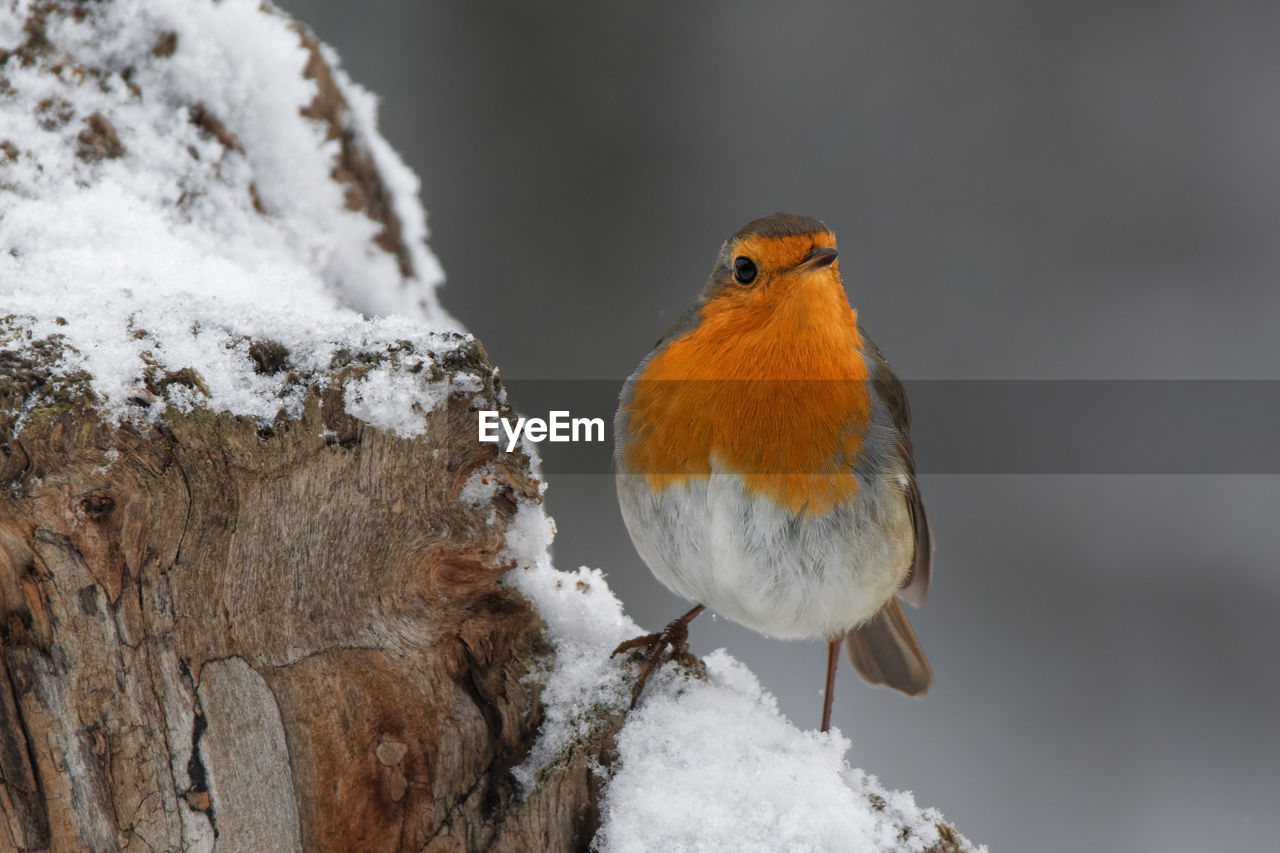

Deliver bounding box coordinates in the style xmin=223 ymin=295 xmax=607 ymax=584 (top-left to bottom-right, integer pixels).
xmin=0 ymin=0 xmax=974 ymax=853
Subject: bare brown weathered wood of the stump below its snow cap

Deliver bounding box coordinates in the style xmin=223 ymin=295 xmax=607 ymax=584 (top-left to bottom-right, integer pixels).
xmin=0 ymin=321 xmax=621 ymax=850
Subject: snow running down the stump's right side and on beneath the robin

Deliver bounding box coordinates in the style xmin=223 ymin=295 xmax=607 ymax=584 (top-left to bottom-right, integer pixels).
xmin=506 ymin=501 xmax=986 ymax=853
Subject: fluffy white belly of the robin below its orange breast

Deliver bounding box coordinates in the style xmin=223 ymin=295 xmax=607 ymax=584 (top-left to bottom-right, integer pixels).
xmin=617 ymin=458 xmax=914 ymax=639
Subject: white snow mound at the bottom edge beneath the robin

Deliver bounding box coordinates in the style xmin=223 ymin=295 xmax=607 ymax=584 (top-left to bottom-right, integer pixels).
xmin=596 ymin=649 xmax=962 ymax=853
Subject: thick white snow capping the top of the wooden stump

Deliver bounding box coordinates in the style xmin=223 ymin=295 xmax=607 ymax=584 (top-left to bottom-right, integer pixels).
xmin=0 ymin=0 xmax=466 ymax=427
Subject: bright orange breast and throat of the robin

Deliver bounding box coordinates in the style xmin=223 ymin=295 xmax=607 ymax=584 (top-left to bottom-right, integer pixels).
xmin=623 ymin=275 xmax=870 ymax=514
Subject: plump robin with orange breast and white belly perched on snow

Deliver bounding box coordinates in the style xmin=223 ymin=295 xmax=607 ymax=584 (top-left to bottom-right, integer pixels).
xmin=614 ymin=213 xmax=933 ymax=731
